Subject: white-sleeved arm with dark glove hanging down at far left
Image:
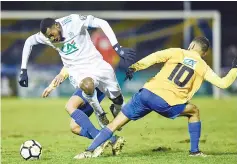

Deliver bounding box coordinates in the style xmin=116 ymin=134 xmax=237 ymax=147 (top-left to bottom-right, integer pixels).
xmin=19 ymin=34 xmax=40 ymax=87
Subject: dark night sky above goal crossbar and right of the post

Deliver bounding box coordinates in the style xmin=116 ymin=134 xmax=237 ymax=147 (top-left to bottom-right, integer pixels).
xmin=1 ymin=1 xmax=237 ymax=53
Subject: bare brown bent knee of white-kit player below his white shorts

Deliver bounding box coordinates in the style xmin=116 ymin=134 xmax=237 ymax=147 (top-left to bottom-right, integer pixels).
xmin=79 ymin=77 xmax=95 ymax=95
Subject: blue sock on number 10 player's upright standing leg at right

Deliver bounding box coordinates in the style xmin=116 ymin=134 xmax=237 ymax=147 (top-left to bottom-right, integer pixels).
xmin=188 ymin=121 xmax=201 ymax=152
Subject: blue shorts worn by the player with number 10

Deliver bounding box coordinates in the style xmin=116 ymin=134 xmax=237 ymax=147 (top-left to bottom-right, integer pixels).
xmin=122 ymin=88 xmax=186 ymax=120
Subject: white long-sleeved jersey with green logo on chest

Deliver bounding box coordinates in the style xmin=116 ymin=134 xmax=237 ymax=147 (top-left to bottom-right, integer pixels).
xmin=22 ymin=14 xmax=117 ymax=69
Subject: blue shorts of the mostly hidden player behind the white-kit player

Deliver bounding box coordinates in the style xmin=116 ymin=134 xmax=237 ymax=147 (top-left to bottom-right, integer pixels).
xmin=72 ymin=88 xmax=105 ymax=117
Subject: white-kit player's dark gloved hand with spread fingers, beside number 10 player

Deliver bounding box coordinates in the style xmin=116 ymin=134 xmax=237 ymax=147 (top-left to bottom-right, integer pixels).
xmin=113 ymin=43 xmax=136 ymax=62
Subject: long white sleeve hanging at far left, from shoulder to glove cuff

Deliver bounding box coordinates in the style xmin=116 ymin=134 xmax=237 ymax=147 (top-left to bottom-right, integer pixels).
xmin=21 ymin=33 xmax=44 ymax=69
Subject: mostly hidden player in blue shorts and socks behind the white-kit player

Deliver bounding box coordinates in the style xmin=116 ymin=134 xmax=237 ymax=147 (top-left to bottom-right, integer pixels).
xmin=42 ymin=68 xmax=124 ymax=158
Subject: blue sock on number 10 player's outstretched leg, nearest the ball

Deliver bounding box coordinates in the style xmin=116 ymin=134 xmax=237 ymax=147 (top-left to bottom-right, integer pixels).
xmin=87 ymin=127 xmax=113 ymax=151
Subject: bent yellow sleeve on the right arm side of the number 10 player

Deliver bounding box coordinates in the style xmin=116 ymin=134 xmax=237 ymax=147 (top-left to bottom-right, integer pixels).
xmin=204 ymin=67 xmax=237 ymax=89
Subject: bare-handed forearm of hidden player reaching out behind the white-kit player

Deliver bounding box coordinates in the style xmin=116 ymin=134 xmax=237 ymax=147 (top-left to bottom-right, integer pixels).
xmin=42 ymin=67 xmax=69 ymax=98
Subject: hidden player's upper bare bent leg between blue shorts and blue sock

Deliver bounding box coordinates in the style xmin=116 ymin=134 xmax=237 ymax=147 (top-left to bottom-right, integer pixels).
xmin=65 ymin=95 xmax=85 ymax=115
